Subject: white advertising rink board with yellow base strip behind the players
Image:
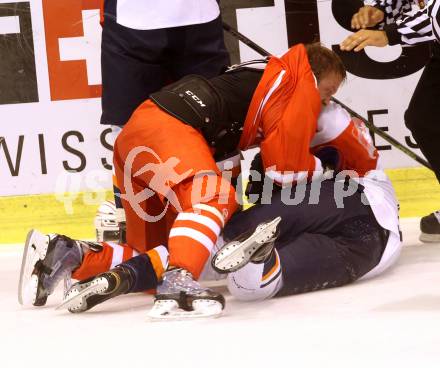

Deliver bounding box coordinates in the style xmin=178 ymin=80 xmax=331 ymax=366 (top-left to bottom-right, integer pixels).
xmin=0 ymin=0 xmax=440 ymax=243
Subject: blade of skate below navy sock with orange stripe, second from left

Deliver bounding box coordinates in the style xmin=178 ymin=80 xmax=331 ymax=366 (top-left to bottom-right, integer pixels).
xmin=55 ymin=277 xmax=108 ymax=313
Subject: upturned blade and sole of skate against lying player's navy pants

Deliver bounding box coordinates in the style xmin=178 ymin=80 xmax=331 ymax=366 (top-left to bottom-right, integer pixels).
xmin=212 ymin=216 xmax=281 ymax=273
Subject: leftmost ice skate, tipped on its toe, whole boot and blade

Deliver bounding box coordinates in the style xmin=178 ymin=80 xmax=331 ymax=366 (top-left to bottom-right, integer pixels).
xmin=18 ymin=230 xmax=83 ymax=306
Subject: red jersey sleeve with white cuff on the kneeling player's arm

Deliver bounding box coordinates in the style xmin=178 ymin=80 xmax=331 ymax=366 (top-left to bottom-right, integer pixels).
xmin=260 ymin=45 xmax=322 ymax=184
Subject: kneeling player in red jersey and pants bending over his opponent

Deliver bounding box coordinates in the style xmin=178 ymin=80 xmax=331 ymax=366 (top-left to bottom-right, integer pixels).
xmin=18 ymin=44 xmax=345 ymax=320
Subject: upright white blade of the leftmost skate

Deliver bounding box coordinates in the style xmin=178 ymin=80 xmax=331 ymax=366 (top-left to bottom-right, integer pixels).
xmin=18 ymin=230 xmax=49 ymax=306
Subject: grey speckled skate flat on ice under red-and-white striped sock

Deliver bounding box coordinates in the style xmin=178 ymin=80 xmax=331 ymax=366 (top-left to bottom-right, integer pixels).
xmin=148 ymin=268 xmax=225 ymax=320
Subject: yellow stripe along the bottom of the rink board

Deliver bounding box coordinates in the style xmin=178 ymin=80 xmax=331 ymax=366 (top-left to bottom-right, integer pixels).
xmin=0 ymin=168 xmax=440 ymax=244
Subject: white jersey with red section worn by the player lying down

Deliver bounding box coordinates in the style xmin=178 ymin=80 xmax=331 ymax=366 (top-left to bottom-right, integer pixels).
xmin=311 ymin=102 xmax=402 ymax=278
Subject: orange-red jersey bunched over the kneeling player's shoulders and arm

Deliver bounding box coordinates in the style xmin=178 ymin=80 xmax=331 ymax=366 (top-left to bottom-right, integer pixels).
xmin=239 ymin=44 xmax=322 ymax=184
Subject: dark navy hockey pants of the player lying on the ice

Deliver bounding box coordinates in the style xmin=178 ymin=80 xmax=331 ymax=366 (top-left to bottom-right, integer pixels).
xmin=224 ymin=181 xmax=388 ymax=295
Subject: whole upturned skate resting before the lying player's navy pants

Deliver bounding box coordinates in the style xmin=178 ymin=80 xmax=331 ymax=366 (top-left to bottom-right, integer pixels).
xmin=211 ymin=217 xmax=281 ymax=273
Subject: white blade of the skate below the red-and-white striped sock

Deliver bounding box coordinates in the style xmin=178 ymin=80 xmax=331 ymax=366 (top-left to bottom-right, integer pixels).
xmin=148 ymin=299 xmax=223 ymax=322
